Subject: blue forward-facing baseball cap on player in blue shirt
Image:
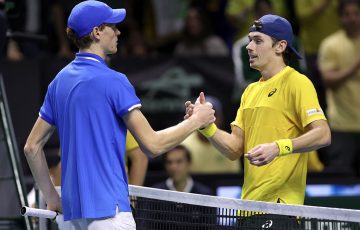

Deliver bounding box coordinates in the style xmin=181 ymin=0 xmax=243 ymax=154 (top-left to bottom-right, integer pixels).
xmin=67 ymin=0 xmax=126 ymax=38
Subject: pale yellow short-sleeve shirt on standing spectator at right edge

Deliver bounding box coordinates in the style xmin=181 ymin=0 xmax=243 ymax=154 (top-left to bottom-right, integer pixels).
xmin=319 ymin=30 xmax=360 ymax=132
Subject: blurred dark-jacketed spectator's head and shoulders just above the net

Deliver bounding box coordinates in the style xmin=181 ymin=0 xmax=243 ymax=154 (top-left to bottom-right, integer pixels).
xmin=153 ymin=145 xmax=214 ymax=195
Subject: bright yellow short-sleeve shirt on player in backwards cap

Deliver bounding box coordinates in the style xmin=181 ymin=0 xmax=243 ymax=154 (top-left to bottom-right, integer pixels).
xmin=231 ymin=67 xmax=326 ymax=204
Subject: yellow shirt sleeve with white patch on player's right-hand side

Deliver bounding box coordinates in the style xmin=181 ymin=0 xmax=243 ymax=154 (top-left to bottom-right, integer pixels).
xmin=292 ymin=75 xmax=326 ymax=127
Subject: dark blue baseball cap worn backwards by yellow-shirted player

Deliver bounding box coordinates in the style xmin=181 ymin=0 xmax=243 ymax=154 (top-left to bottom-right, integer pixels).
xmin=249 ymin=14 xmax=302 ymax=59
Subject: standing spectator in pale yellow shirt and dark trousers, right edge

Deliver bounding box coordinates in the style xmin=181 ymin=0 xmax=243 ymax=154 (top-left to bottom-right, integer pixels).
xmin=319 ymin=0 xmax=360 ymax=175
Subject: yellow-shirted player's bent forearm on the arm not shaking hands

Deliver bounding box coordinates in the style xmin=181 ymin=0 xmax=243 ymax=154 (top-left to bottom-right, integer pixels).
xmin=292 ymin=121 xmax=331 ymax=153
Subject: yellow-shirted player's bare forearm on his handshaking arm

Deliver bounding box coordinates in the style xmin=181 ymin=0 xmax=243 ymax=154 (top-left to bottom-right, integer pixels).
xmin=209 ymin=129 xmax=243 ymax=160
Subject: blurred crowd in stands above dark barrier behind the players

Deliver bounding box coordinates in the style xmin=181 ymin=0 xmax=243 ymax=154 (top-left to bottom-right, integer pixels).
xmin=0 ymin=0 xmax=339 ymax=61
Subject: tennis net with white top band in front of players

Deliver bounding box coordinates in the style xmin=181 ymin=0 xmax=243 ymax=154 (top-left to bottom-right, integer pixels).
xmin=130 ymin=186 xmax=360 ymax=230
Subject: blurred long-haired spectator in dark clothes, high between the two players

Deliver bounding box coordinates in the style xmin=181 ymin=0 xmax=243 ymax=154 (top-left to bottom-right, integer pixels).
xmin=174 ymin=8 xmax=229 ymax=56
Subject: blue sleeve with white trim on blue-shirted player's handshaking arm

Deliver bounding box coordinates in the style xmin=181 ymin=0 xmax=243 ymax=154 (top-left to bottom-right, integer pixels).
xmin=107 ymin=74 xmax=141 ymax=117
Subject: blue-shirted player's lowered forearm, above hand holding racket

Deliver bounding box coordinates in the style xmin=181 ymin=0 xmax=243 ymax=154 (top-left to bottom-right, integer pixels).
xmin=24 ymin=145 xmax=60 ymax=203
